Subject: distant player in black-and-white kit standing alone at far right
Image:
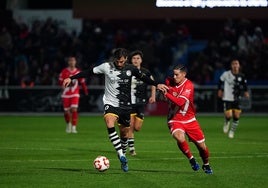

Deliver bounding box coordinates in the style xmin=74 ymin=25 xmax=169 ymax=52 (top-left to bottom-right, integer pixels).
xmin=218 ymin=59 xmax=249 ymax=138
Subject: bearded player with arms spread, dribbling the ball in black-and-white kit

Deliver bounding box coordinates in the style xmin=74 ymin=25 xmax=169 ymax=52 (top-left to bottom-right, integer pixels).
xmin=63 ymin=48 xmax=167 ymax=172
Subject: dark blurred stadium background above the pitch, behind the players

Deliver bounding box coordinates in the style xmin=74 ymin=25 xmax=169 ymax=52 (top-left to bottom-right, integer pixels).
xmin=0 ymin=0 xmax=268 ymax=115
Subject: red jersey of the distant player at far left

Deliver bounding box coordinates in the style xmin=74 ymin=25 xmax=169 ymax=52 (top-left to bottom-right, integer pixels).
xmin=59 ymin=67 xmax=88 ymax=98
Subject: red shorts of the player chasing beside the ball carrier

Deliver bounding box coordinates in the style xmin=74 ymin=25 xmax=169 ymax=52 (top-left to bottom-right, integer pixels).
xmin=168 ymin=121 xmax=205 ymax=143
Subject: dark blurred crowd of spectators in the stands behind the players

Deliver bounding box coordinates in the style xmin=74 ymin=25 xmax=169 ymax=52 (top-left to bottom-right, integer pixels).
xmin=0 ymin=18 xmax=268 ymax=87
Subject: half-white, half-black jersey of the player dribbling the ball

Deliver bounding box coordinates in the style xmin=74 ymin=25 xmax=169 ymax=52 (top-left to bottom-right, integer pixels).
xmin=93 ymin=62 xmax=150 ymax=109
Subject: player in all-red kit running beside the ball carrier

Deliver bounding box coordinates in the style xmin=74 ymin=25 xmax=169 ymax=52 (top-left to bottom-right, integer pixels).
xmin=163 ymin=65 xmax=212 ymax=174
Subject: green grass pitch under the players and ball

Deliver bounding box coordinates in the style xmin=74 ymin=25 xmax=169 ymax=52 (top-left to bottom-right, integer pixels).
xmin=0 ymin=114 xmax=268 ymax=188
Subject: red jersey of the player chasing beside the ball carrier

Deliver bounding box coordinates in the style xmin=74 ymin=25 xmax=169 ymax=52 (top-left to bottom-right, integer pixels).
xmin=166 ymin=78 xmax=196 ymax=123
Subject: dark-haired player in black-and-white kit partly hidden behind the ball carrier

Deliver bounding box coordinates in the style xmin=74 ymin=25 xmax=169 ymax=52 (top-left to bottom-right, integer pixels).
xmin=128 ymin=50 xmax=156 ymax=156
